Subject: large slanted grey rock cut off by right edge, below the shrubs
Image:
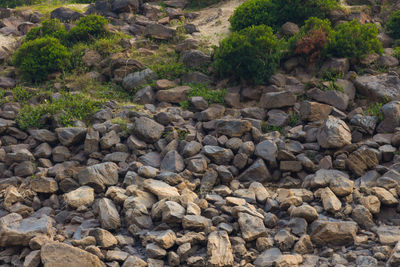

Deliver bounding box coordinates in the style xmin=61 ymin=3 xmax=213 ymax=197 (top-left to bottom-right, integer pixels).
xmin=354 ymin=74 xmax=400 ymax=100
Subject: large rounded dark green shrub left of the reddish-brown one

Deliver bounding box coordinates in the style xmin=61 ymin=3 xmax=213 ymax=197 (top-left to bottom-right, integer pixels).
xmin=214 ymin=25 xmax=284 ymax=84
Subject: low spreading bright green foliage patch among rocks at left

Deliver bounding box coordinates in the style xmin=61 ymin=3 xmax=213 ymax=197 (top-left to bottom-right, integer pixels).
xmin=16 ymin=93 xmax=102 ymax=130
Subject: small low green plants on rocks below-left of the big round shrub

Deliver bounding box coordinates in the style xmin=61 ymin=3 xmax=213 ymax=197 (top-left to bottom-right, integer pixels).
xmin=180 ymin=83 xmax=227 ymax=109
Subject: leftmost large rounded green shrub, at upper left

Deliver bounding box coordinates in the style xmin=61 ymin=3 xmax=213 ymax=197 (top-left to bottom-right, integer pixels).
xmin=13 ymin=37 xmax=71 ymax=81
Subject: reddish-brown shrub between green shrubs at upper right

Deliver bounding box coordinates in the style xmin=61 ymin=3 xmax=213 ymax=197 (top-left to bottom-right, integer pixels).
xmin=295 ymin=29 xmax=328 ymax=63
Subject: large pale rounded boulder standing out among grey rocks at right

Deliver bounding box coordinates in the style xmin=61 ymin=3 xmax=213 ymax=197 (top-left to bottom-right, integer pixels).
xmin=317 ymin=116 xmax=351 ymax=148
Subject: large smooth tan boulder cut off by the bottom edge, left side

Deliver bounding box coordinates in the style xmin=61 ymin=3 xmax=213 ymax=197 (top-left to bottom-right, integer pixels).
xmin=40 ymin=243 xmax=103 ymax=267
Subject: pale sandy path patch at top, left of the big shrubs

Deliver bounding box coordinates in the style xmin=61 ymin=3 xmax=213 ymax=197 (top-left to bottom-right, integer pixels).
xmin=193 ymin=0 xmax=244 ymax=44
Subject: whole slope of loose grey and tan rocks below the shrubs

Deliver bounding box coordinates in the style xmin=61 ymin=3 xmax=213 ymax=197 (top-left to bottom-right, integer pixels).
xmin=0 ymin=0 xmax=400 ymax=267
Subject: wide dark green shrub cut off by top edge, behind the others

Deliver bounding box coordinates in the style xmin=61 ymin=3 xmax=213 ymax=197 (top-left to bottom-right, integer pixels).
xmin=230 ymin=0 xmax=338 ymax=31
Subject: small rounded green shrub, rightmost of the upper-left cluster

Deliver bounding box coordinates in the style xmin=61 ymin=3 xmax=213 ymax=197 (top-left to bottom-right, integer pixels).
xmin=68 ymin=15 xmax=108 ymax=43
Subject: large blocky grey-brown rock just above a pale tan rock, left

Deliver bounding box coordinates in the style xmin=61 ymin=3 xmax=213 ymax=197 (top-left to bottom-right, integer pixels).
xmin=78 ymin=162 xmax=118 ymax=192
